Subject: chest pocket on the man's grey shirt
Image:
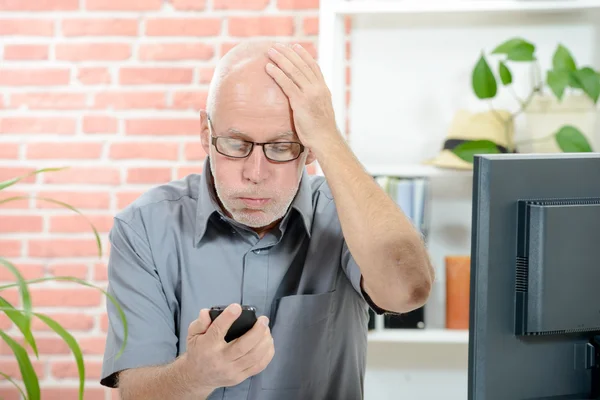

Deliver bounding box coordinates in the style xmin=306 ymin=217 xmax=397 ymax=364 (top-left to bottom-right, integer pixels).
xmin=261 ymin=291 xmax=335 ymax=390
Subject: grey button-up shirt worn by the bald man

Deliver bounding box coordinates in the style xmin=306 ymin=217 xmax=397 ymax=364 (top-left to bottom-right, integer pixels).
xmin=101 ymin=160 xmax=383 ymax=400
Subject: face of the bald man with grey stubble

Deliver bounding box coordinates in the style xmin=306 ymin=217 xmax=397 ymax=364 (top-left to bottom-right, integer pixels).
xmin=202 ymin=67 xmax=312 ymax=229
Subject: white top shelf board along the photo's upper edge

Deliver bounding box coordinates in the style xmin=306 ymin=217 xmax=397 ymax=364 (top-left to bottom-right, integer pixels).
xmin=334 ymin=0 xmax=600 ymax=15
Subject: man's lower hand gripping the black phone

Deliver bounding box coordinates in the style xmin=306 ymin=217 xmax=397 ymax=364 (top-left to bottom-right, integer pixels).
xmin=182 ymin=304 xmax=275 ymax=397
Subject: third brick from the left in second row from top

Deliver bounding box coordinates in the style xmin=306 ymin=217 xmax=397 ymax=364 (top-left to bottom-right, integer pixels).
xmin=146 ymin=18 xmax=221 ymax=36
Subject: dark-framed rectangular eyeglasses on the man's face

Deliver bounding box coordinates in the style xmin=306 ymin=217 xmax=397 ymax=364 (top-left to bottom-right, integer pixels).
xmin=208 ymin=118 xmax=304 ymax=162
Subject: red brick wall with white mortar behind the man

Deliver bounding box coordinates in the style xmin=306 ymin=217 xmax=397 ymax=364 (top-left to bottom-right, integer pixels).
xmin=0 ymin=0 xmax=319 ymax=400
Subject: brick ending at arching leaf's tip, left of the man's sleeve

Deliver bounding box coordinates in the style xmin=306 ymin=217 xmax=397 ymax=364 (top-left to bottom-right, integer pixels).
xmin=29 ymin=239 xmax=98 ymax=258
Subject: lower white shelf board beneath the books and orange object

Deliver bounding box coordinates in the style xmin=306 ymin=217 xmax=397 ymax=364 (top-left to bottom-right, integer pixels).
xmin=368 ymin=329 xmax=469 ymax=344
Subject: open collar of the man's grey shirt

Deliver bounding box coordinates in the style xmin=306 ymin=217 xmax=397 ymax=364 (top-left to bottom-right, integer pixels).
xmin=194 ymin=157 xmax=313 ymax=244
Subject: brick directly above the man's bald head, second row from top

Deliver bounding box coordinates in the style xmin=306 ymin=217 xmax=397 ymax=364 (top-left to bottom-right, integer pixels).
xmin=228 ymin=16 xmax=294 ymax=37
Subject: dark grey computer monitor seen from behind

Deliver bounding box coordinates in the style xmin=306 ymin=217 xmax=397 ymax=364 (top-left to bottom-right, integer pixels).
xmin=468 ymin=153 xmax=600 ymax=400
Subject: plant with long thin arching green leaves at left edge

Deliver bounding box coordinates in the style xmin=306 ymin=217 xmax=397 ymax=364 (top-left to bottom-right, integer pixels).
xmin=0 ymin=168 xmax=127 ymax=400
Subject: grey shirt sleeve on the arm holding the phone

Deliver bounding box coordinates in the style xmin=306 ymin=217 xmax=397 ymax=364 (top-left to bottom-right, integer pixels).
xmin=100 ymin=218 xmax=178 ymax=388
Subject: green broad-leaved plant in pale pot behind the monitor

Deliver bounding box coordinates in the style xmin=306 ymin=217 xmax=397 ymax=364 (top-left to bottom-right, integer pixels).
xmin=453 ymin=37 xmax=600 ymax=162
